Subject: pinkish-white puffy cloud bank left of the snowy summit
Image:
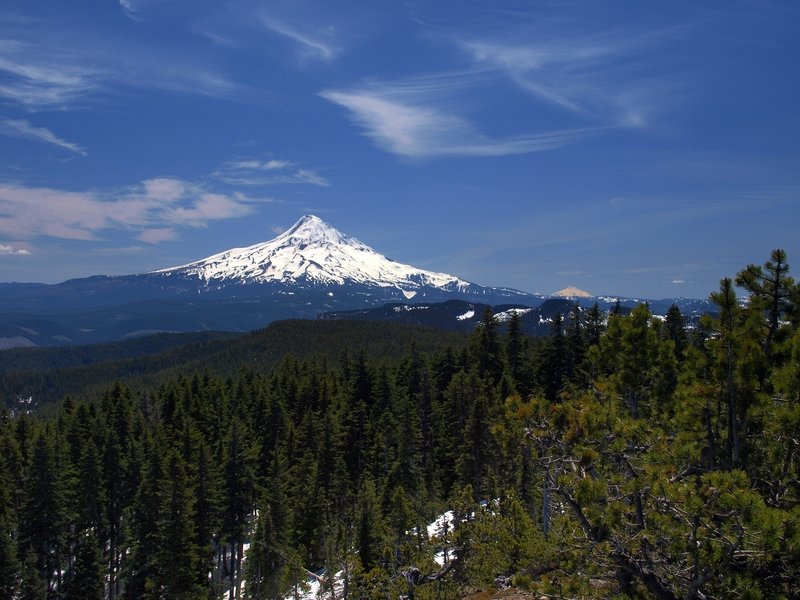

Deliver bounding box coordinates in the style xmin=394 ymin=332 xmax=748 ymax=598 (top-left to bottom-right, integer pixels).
xmin=0 ymin=178 xmax=270 ymax=243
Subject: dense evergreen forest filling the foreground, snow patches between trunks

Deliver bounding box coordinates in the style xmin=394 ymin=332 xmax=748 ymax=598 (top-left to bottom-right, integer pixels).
xmin=0 ymin=250 xmax=800 ymax=600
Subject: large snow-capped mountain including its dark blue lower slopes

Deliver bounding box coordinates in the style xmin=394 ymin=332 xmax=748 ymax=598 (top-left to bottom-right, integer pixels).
xmin=0 ymin=215 xmax=543 ymax=349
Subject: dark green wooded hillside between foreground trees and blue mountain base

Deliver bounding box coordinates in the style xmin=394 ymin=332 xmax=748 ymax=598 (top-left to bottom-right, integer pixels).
xmin=0 ymin=320 xmax=466 ymax=406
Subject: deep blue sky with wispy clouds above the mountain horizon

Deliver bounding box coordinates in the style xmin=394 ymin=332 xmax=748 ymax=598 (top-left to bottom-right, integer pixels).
xmin=0 ymin=0 xmax=800 ymax=298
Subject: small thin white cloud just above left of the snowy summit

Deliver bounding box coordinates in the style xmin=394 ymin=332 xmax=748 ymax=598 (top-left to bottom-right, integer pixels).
xmin=212 ymin=158 xmax=330 ymax=187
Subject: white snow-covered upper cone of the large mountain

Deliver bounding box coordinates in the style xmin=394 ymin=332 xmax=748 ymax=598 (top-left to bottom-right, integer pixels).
xmin=156 ymin=215 xmax=470 ymax=298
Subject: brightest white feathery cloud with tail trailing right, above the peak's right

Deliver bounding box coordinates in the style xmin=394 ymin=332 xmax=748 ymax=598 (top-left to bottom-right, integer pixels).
xmin=320 ymin=80 xmax=597 ymax=158
